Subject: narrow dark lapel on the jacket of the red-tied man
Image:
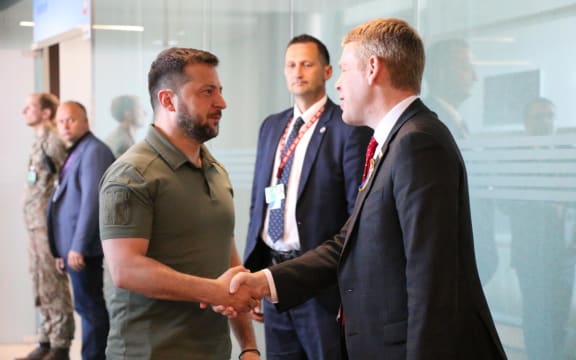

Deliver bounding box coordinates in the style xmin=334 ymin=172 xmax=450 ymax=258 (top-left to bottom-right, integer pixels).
xmin=342 ymin=99 xmax=425 ymax=254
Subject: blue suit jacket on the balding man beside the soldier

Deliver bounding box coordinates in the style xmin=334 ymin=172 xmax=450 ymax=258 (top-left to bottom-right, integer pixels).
xmin=48 ymin=132 xmax=114 ymax=259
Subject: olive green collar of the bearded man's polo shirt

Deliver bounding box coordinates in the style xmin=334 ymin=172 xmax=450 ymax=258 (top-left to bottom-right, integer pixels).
xmin=146 ymin=124 xmax=217 ymax=171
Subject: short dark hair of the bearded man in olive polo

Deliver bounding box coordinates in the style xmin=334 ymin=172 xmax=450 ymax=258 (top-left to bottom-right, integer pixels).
xmin=148 ymin=48 xmax=218 ymax=110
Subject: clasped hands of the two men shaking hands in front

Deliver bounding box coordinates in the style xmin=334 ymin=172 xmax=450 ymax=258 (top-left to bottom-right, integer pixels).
xmin=200 ymin=266 xmax=270 ymax=318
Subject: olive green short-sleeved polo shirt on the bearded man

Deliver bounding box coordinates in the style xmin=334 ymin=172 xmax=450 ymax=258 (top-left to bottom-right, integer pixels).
xmin=100 ymin=126 xmax=234 ymax=360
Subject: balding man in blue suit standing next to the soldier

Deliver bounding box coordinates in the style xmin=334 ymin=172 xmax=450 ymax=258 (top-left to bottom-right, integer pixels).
xmin=48 ymin=101 xmax=114 ymax=360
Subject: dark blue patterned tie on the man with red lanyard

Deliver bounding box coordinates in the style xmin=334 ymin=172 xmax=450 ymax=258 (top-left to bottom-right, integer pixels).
xmin=268 ymin=117 xmax=304 ymax=242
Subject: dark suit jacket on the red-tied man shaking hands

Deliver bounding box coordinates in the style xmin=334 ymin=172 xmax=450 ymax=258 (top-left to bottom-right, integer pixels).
xmin=271 ymin=100 xmax=506 ymax=360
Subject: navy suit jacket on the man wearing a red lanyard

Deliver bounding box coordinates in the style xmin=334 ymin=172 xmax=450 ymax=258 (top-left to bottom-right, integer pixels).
xmin=244 ymin=99 xmax=372 ymax=311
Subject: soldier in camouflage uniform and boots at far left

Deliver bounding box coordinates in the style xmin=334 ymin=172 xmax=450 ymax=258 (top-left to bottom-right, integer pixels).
xmin=21 ymin=93 xmax=74 ymax=360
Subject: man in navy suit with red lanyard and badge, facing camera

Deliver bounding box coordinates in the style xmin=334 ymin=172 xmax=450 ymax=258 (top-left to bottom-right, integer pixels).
xmin=245 ymin=35 xmax=371 ymax=360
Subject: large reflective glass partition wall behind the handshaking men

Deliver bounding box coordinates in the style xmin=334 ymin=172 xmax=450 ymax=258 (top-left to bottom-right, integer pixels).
xmin=86 ymin=0 xmax=576 ymax=360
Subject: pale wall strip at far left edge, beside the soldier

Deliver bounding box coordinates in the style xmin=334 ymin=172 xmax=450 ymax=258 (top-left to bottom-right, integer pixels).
xmin=0 ymin=50 xmax=36 ymax=343
